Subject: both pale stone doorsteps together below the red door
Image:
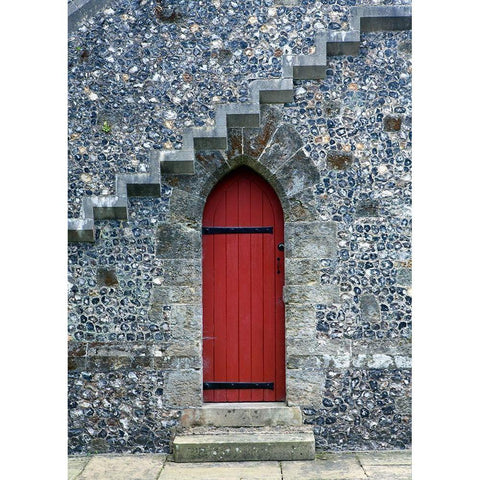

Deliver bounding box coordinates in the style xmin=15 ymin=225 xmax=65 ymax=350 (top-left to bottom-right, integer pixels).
xmin=173 ymin=402 xmax=315 ymax=463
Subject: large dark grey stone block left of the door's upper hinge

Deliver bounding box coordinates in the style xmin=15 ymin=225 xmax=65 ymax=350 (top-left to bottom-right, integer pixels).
xmin=156 ymin=223 xmax=202 ymax=258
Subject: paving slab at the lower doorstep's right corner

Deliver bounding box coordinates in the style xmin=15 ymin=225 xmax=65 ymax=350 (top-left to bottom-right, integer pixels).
xmin=282 ymin=453 xmax=366 ymax=480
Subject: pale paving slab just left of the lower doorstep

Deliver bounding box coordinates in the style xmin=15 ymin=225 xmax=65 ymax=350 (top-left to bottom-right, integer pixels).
xmin=75 ymin=454 xmax=167 ymax=480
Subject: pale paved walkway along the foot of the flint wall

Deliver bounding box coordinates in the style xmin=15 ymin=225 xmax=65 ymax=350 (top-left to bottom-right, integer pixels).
xmin=68 ymin=450 xmax=412 ymax=480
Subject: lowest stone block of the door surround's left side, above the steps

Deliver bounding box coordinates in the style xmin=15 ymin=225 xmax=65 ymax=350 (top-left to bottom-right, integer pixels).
xmin=163 ymin=370 xmax=203 ymax=408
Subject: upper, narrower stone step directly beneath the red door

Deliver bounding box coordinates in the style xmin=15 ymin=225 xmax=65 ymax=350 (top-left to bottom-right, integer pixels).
xmin=180 ymin=402 xmax=303 ymax=428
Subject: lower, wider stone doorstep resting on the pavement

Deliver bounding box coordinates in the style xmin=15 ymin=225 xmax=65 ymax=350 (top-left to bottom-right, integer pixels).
xmin=173 ymin=428 xmax=315 ymax=463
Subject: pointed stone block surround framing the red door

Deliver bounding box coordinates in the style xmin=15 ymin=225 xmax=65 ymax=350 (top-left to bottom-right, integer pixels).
xmin=156 ymin=106 xmax=339 ymax=408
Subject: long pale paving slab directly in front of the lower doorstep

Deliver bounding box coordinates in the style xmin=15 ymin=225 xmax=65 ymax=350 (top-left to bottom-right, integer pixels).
xmin=158 ymin=462 xmax=282 ymax=480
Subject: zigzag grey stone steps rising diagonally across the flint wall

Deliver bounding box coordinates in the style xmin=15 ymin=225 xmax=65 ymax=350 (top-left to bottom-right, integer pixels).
xmin=68 ymin=6 xmax=412 ymax=242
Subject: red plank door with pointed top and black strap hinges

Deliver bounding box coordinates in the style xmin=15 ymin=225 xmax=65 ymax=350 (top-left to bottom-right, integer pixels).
xmin=202 ymin=167 xmax=285 ymax=402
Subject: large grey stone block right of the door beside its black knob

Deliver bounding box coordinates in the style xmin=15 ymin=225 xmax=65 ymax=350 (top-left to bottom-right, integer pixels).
xmin=285 ymin=222 xmax=337 ymax=259
